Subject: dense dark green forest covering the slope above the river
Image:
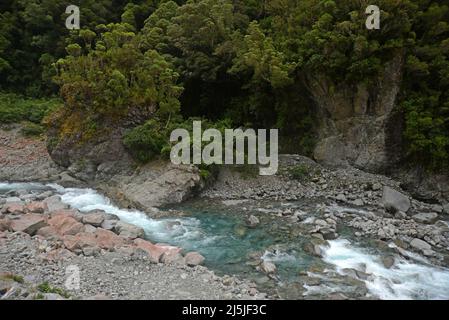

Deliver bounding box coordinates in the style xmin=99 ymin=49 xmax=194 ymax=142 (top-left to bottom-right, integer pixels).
xmin=0 ymin=0 xmax=449 ymax=168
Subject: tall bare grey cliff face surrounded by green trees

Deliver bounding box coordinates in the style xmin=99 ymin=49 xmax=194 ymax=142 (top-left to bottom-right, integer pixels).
xmin=306 ymin=54 xmax=403 ymax=172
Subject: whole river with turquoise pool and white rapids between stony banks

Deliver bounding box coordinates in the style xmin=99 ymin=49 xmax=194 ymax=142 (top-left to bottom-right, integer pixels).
xmin=0 ymin=183 xmax=449 ymax=299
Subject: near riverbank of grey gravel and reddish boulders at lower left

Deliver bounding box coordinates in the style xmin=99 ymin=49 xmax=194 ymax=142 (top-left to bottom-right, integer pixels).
xmin=0 ymin=190 xmax=265 ymax=299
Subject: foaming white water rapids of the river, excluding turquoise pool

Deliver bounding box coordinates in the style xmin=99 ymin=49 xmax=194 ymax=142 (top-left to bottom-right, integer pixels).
xmin=0 ymin=183 xmax=449 ymax=299
